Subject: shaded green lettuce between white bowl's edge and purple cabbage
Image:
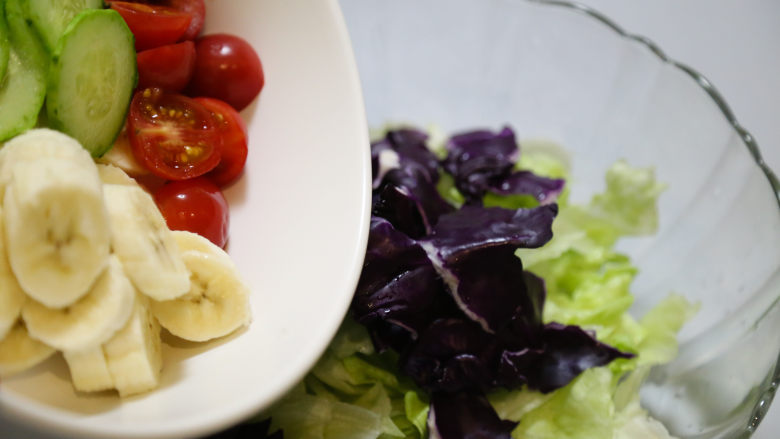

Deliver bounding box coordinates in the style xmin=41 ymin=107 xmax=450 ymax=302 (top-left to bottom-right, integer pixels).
xmin=266 ymin=317 xmax=428 ymax=439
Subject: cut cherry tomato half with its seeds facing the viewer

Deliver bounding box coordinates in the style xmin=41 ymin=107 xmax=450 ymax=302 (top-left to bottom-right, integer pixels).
xmin=127 ymin=88 xmax=220 ymax=180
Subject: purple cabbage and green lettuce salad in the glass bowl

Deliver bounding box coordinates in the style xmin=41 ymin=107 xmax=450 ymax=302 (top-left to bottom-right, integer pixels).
xmin=213 ymin=127 xmax=695 ymax=439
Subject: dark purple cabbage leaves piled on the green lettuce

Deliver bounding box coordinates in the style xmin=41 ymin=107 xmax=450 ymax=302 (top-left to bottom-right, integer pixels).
xmin=351 ymin=127 xmax=632 ymax=439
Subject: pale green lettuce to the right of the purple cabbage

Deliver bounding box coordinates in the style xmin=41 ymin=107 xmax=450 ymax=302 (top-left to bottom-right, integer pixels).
xmin=490 ymin=154 xmax=696 ymax=439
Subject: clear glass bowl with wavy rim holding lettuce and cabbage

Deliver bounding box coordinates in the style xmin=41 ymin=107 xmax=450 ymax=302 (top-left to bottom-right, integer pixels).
xmin=341 ymin=0 xmax=780 ymax=438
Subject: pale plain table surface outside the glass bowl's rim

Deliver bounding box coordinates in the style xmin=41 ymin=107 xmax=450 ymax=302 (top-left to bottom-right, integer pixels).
xmin=580 ymin=0 xmax=780 ymax=439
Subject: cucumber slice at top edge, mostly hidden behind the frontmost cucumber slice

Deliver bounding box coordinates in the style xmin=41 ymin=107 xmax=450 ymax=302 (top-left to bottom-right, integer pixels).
xmin=25 ymin=0 xmax=103 ymax=51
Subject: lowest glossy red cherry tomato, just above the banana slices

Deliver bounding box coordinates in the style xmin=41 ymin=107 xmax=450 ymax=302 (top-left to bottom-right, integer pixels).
xmin=154 ymin=177 xmax=230 ymax=247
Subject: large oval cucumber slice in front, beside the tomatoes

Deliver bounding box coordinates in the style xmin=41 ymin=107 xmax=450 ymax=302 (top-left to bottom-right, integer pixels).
xmin=46 ymin=9 xmax=138 ymax=157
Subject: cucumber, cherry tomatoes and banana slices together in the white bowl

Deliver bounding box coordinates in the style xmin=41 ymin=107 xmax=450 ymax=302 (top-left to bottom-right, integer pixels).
xmin=0 ymin=0 xmax=264 ymax=397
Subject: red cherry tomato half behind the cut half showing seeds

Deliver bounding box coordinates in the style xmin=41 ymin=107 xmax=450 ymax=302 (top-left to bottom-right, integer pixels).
xmin=195 ymin=98 xmax=248 ymax=187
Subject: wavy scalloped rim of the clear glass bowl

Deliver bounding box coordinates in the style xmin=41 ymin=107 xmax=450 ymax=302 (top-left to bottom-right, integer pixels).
xmin=526 ymin=0 xmax=780 ymax=438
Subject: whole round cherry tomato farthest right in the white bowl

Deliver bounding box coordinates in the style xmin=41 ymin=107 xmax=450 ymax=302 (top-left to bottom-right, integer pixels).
xmin=188 ymin=34 xmax=265 ymax=111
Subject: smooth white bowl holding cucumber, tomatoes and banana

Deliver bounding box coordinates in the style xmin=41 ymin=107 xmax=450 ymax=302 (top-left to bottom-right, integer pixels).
xmin=0 ymin=0 xmax=370 ymax=438
